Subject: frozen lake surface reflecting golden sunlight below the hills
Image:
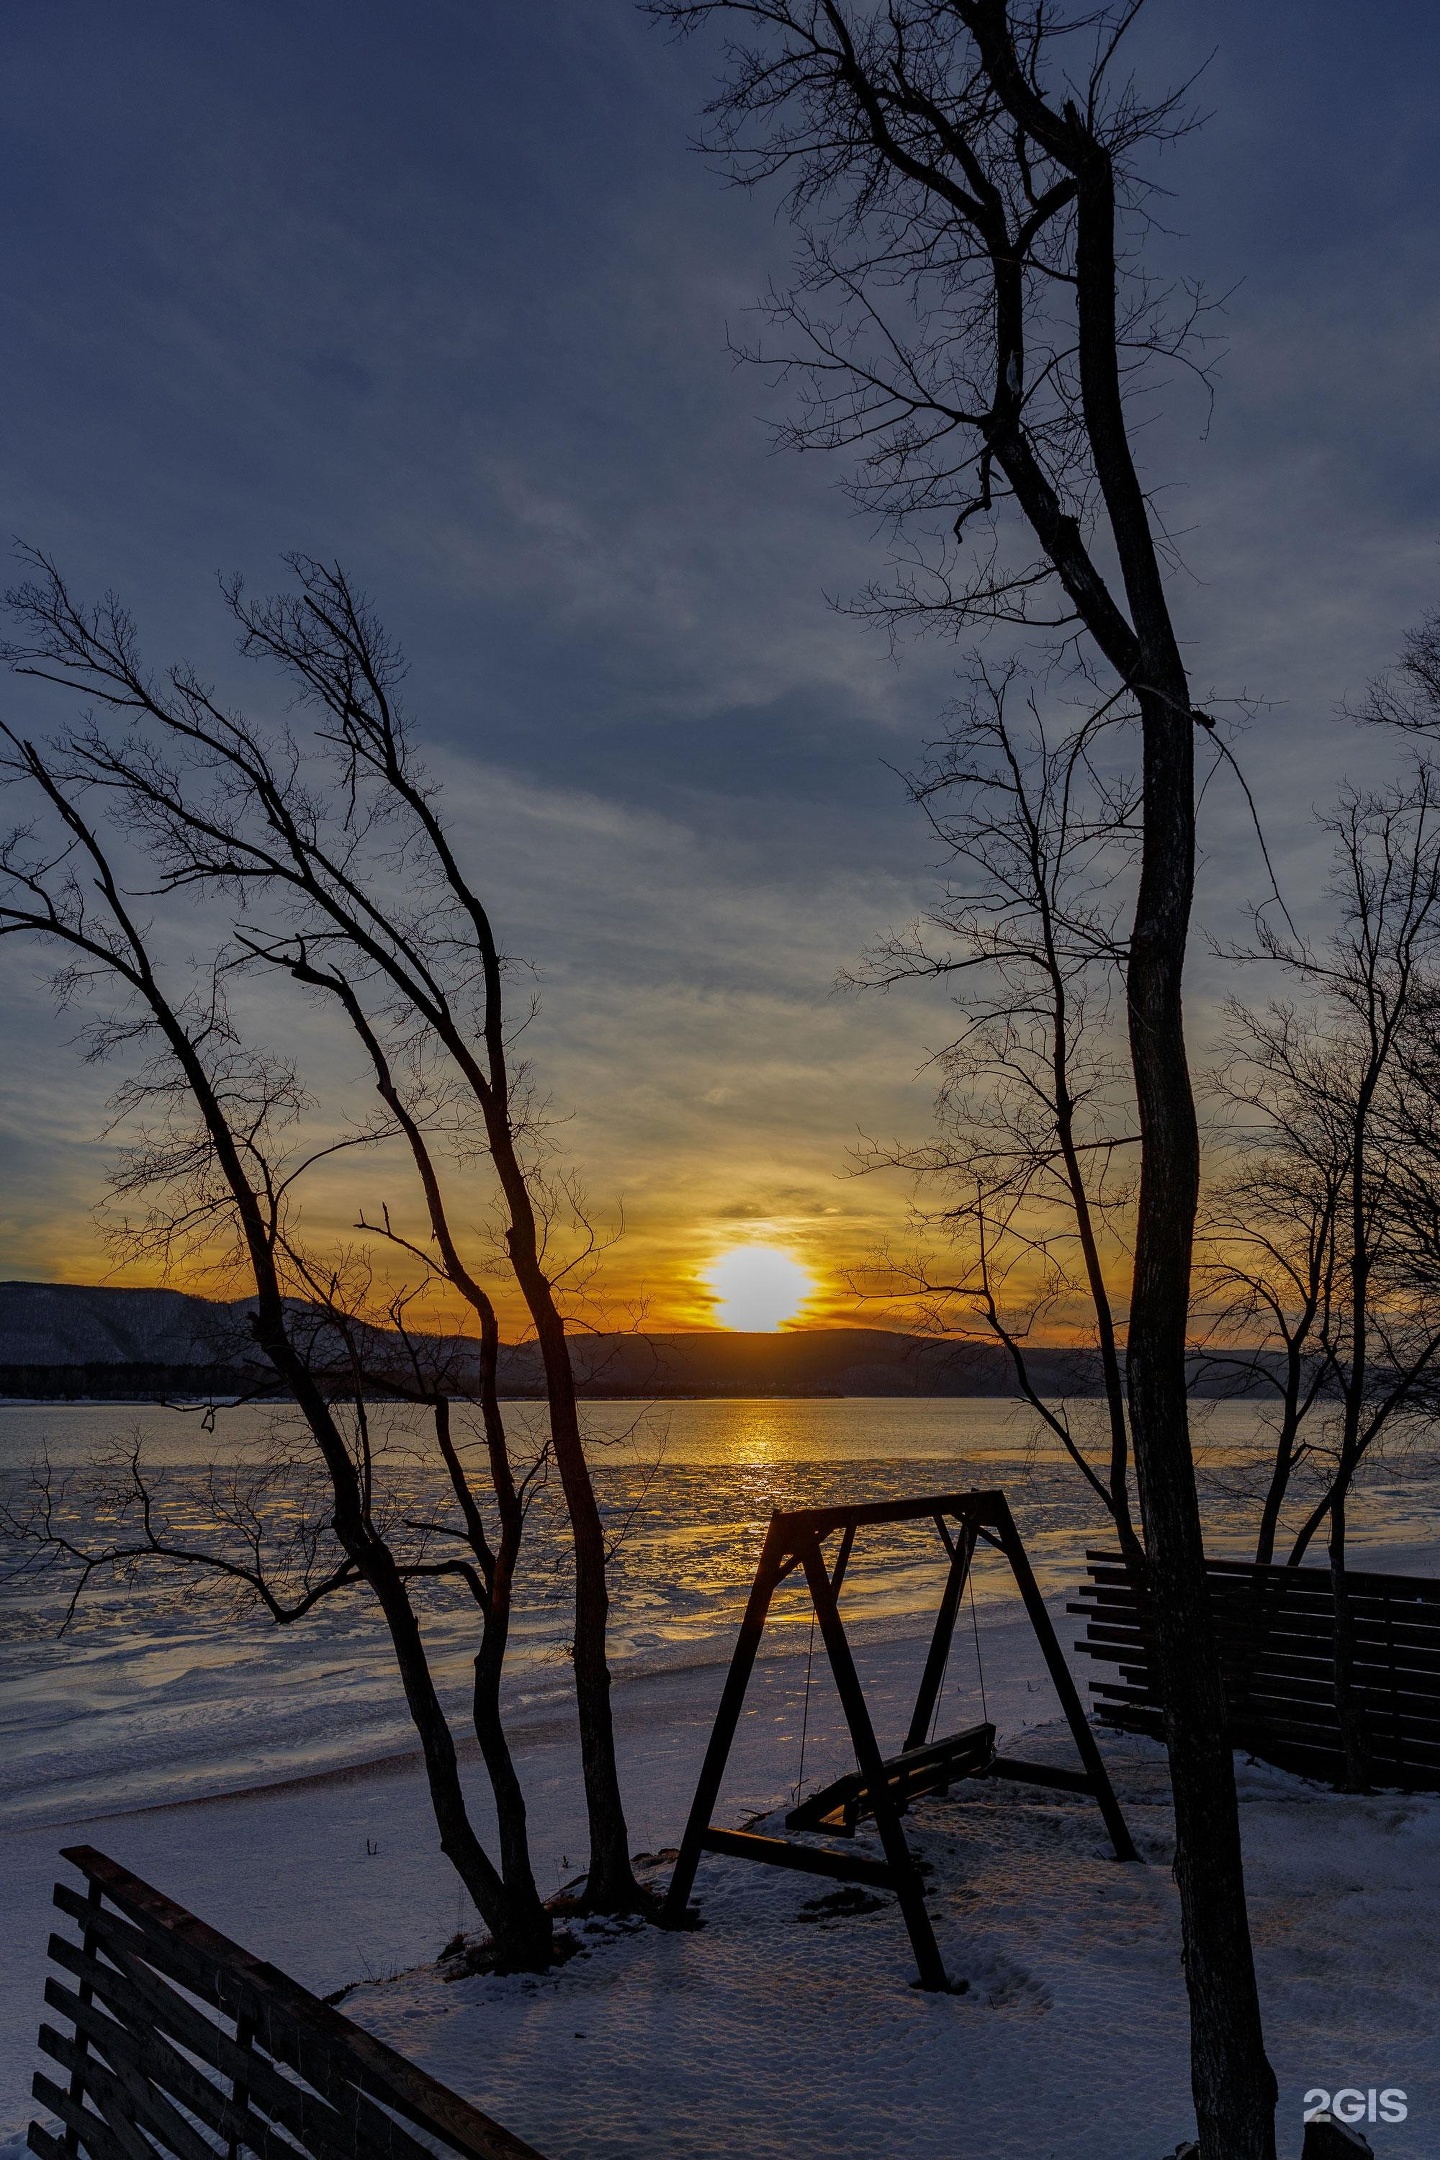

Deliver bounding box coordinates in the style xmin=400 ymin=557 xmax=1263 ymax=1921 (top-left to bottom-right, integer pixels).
xmin=0 ymin=1398 xmax=1440 ymax=1827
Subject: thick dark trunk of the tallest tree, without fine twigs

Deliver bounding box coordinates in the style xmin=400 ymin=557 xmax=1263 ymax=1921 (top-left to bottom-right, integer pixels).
xmin=961 ymin=38 xmax=1276 ymax=2160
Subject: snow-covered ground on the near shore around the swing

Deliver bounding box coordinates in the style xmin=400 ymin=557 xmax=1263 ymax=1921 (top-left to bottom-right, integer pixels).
xmin=0 ymin=1589 xmax=1440 ymax=2160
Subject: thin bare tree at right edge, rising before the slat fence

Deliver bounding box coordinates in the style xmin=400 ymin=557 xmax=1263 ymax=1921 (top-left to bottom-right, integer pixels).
xmin=1215 ymin=765 xmax=1440 ymax=1788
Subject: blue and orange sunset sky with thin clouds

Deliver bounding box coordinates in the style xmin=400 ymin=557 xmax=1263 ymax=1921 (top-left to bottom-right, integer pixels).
xmin=0 ymin=0 xmax=1440 ymax=1326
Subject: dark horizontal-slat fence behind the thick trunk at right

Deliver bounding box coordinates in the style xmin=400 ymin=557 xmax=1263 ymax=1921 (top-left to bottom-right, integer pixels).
xmin=1069 ymin=1553 xmax=1440 ymax=1793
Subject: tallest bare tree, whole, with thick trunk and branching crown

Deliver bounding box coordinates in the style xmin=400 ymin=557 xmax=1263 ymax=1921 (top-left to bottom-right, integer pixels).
xmin=650 ymin=0 xmax=1276 ymax=2160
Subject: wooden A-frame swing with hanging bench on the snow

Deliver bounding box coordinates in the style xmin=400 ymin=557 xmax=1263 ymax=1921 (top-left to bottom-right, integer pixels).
xmin=663 ymin=1493 xmax=1140 ymax=1989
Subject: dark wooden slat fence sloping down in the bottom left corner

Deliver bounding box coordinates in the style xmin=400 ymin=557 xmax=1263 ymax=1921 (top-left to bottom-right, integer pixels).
xmin=28 ymin=1845 xmax=540 ymax=2160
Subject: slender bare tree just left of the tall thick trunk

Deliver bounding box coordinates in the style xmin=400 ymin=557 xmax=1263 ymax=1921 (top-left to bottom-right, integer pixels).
xmin=855 ymin=665 xmax=1144 ymax=1566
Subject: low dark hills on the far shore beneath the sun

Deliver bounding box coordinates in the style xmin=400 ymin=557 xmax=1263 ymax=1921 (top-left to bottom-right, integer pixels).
xmin=0 ymin=1283 xmax=1269 ymax=1402
